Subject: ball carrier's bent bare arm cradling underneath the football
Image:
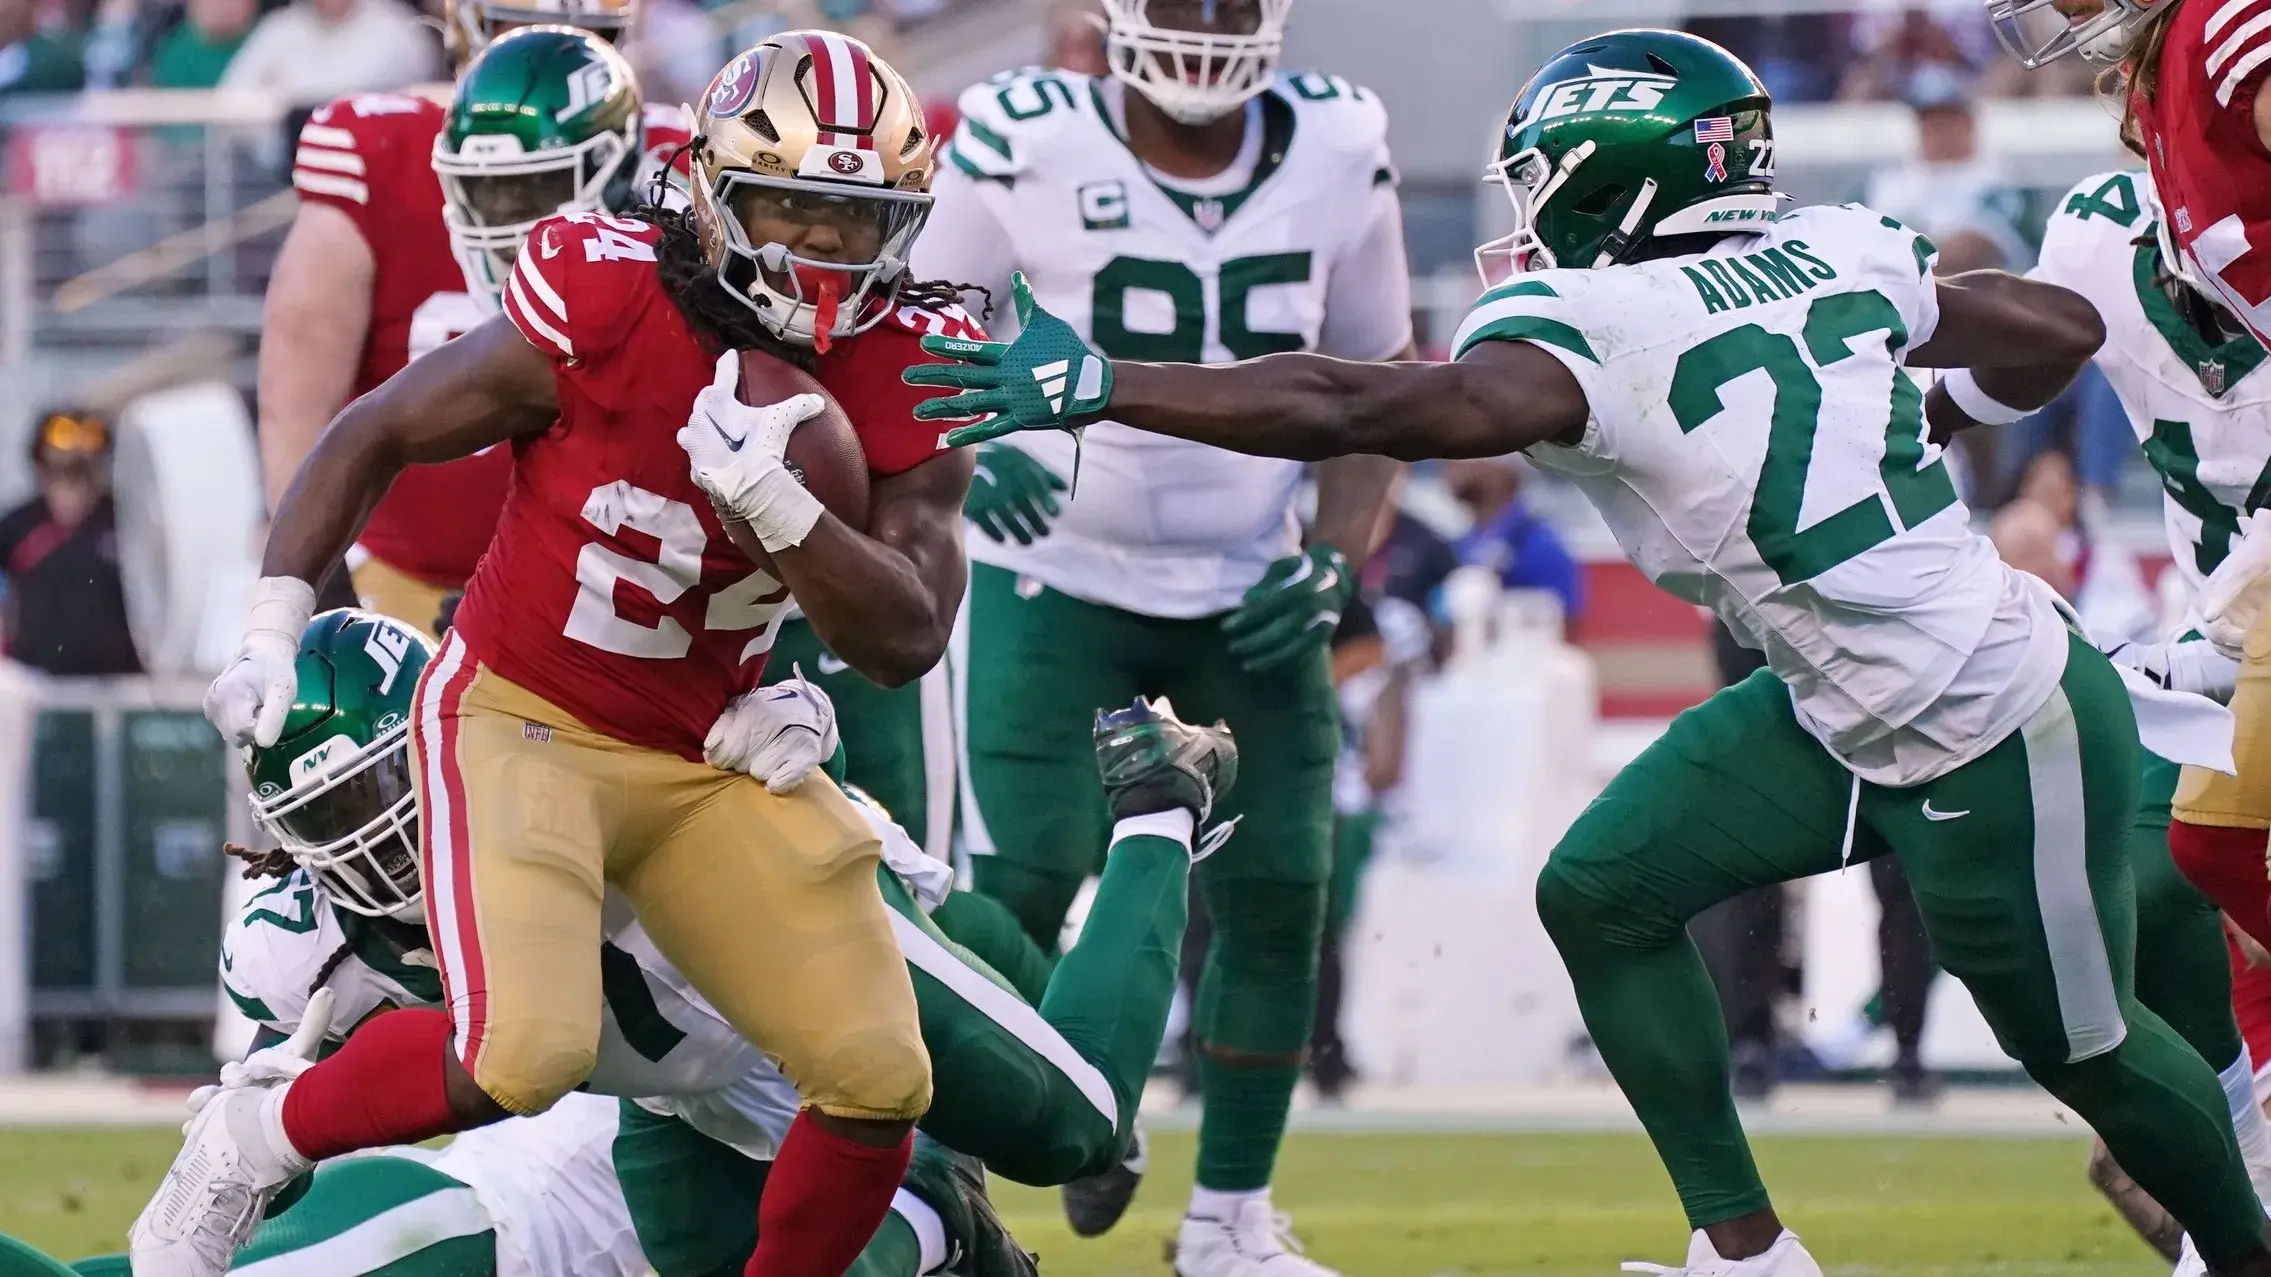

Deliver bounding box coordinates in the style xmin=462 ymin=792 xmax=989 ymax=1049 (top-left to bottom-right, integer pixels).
xmin=772 ymin=448 xmax=974 ymax=686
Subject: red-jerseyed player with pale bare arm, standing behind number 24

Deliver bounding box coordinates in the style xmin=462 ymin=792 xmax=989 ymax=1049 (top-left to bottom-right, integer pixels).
xmin=259 ymin=0 xmax=688 ymax=632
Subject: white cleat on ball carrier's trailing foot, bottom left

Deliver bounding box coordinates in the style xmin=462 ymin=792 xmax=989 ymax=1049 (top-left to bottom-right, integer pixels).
xmin=127 ymin=1084 xmax=311 ymax=1277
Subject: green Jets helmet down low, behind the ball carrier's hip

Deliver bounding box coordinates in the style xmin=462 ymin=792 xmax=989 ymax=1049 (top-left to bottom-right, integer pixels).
xmin=245 ymin=607 xmax=434 ymax=923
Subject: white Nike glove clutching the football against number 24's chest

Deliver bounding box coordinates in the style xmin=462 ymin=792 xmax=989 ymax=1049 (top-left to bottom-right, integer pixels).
xmin=679 ymin=350 xmax=829 ymax=550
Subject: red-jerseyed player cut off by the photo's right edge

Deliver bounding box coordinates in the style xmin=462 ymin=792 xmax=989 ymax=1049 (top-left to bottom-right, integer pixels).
xmin=1987 ymin=0 xmax=2271 ymax=1008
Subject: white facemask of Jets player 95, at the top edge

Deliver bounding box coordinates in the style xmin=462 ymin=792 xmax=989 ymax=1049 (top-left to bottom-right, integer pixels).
xmin=1104 ymin=0 xmax=1292 ymax=125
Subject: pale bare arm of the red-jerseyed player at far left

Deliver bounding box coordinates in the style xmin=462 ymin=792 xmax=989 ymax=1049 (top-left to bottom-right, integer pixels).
xmin=259 ymin=202 xmax=375 ymax=509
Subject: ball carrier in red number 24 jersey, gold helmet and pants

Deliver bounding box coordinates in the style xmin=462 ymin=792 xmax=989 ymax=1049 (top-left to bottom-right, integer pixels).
xmin=132 ymin=32 xmax=974 ymax=1277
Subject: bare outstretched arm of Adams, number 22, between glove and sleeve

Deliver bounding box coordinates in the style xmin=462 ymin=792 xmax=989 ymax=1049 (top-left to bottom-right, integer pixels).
xmin=1104 ymin=341 xmax=1585 ymax=461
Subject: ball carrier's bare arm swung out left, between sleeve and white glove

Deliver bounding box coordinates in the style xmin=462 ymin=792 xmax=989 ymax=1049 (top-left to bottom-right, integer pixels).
xmin=261 ymin=316 xmax=559 ymax=582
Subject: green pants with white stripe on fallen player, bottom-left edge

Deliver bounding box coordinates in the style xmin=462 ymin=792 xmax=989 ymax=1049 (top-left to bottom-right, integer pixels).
xmin=73 ymin=1154 xmax=497 ymax=1277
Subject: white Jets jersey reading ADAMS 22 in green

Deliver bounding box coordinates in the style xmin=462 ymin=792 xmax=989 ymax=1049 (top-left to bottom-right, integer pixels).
xmin=1453 ymin=205 xmax=2067 ymax=786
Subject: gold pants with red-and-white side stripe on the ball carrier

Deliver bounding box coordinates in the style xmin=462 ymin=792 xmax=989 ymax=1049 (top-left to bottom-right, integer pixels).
xmin=411 ymin=636 xmax=931 ymax=1118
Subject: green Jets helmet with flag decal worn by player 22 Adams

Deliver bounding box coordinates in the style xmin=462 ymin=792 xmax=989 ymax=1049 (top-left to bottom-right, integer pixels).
xmin=1474 ymin=30 xmax=1778 ymax=282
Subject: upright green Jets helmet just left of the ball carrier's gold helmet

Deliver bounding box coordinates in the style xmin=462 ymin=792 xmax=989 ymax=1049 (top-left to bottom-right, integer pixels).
xmin=434 ymin=27 xmax=645 ymax=300
